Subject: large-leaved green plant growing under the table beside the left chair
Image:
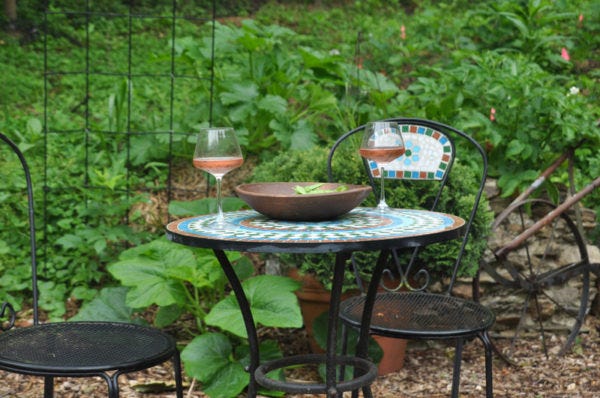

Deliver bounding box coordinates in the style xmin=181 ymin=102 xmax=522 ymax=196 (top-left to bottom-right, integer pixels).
xmin=73 ymin=198 xmax=302 ymax=397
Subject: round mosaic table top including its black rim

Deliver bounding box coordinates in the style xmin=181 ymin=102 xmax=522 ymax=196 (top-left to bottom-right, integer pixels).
xmin=166 ymin=207 xmax=465 ymax=253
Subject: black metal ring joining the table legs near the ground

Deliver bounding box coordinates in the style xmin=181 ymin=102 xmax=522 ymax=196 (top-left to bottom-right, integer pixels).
xmin=254 ymin=354 xmax=377 ymax=397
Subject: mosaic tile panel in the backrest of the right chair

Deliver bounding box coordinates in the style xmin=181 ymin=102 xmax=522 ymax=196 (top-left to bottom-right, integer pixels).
xmin=369 ymin=124 xmax=453 ymax=180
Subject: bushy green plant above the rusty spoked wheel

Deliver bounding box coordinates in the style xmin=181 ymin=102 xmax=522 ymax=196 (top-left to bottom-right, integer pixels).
xmin=408 ymin=51 xmax=600 ymax=196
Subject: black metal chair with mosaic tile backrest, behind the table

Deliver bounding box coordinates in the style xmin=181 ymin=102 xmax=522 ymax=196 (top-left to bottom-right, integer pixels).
xmin=327 ymin=118 xmax=495 ymax=398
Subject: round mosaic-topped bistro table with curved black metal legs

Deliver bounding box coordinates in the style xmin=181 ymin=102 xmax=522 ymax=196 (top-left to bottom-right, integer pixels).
xmin=166 ymin=207 xmax=464 ymax=397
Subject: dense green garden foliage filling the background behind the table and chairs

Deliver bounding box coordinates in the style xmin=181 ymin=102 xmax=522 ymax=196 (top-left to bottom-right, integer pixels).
xmin=0 ymin=0 xmax=600 ymax=338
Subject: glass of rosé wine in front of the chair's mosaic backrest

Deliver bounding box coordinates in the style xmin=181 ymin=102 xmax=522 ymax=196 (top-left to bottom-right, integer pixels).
xmin=359 ymin=121 xmax=405 ymax=212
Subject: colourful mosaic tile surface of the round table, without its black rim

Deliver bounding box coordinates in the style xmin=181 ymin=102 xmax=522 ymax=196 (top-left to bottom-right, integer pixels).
xmin=167 ymin=207 xmax=463 ymax=243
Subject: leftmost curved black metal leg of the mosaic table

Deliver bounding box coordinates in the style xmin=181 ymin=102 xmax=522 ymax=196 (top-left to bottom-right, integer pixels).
xmin=213 ymin=249 xmax=260 ymax=398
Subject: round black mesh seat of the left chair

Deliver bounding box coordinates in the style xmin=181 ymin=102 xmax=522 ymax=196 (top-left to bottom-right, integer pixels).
xmin=0 ymin=322 xmax=177 ymax=375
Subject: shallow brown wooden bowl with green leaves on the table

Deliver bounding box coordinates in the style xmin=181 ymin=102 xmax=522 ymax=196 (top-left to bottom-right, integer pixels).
xmin=235 ymin=182 xmax=371 ymax=221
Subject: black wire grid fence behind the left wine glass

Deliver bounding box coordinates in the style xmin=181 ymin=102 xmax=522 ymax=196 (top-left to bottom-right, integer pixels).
xmin=38 ymin=0 xmax=217 ymax=284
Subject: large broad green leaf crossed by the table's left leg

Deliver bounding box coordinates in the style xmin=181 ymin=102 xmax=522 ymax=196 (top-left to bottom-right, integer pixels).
xmin=205 ymin=275 xmax=302 ymax=338
